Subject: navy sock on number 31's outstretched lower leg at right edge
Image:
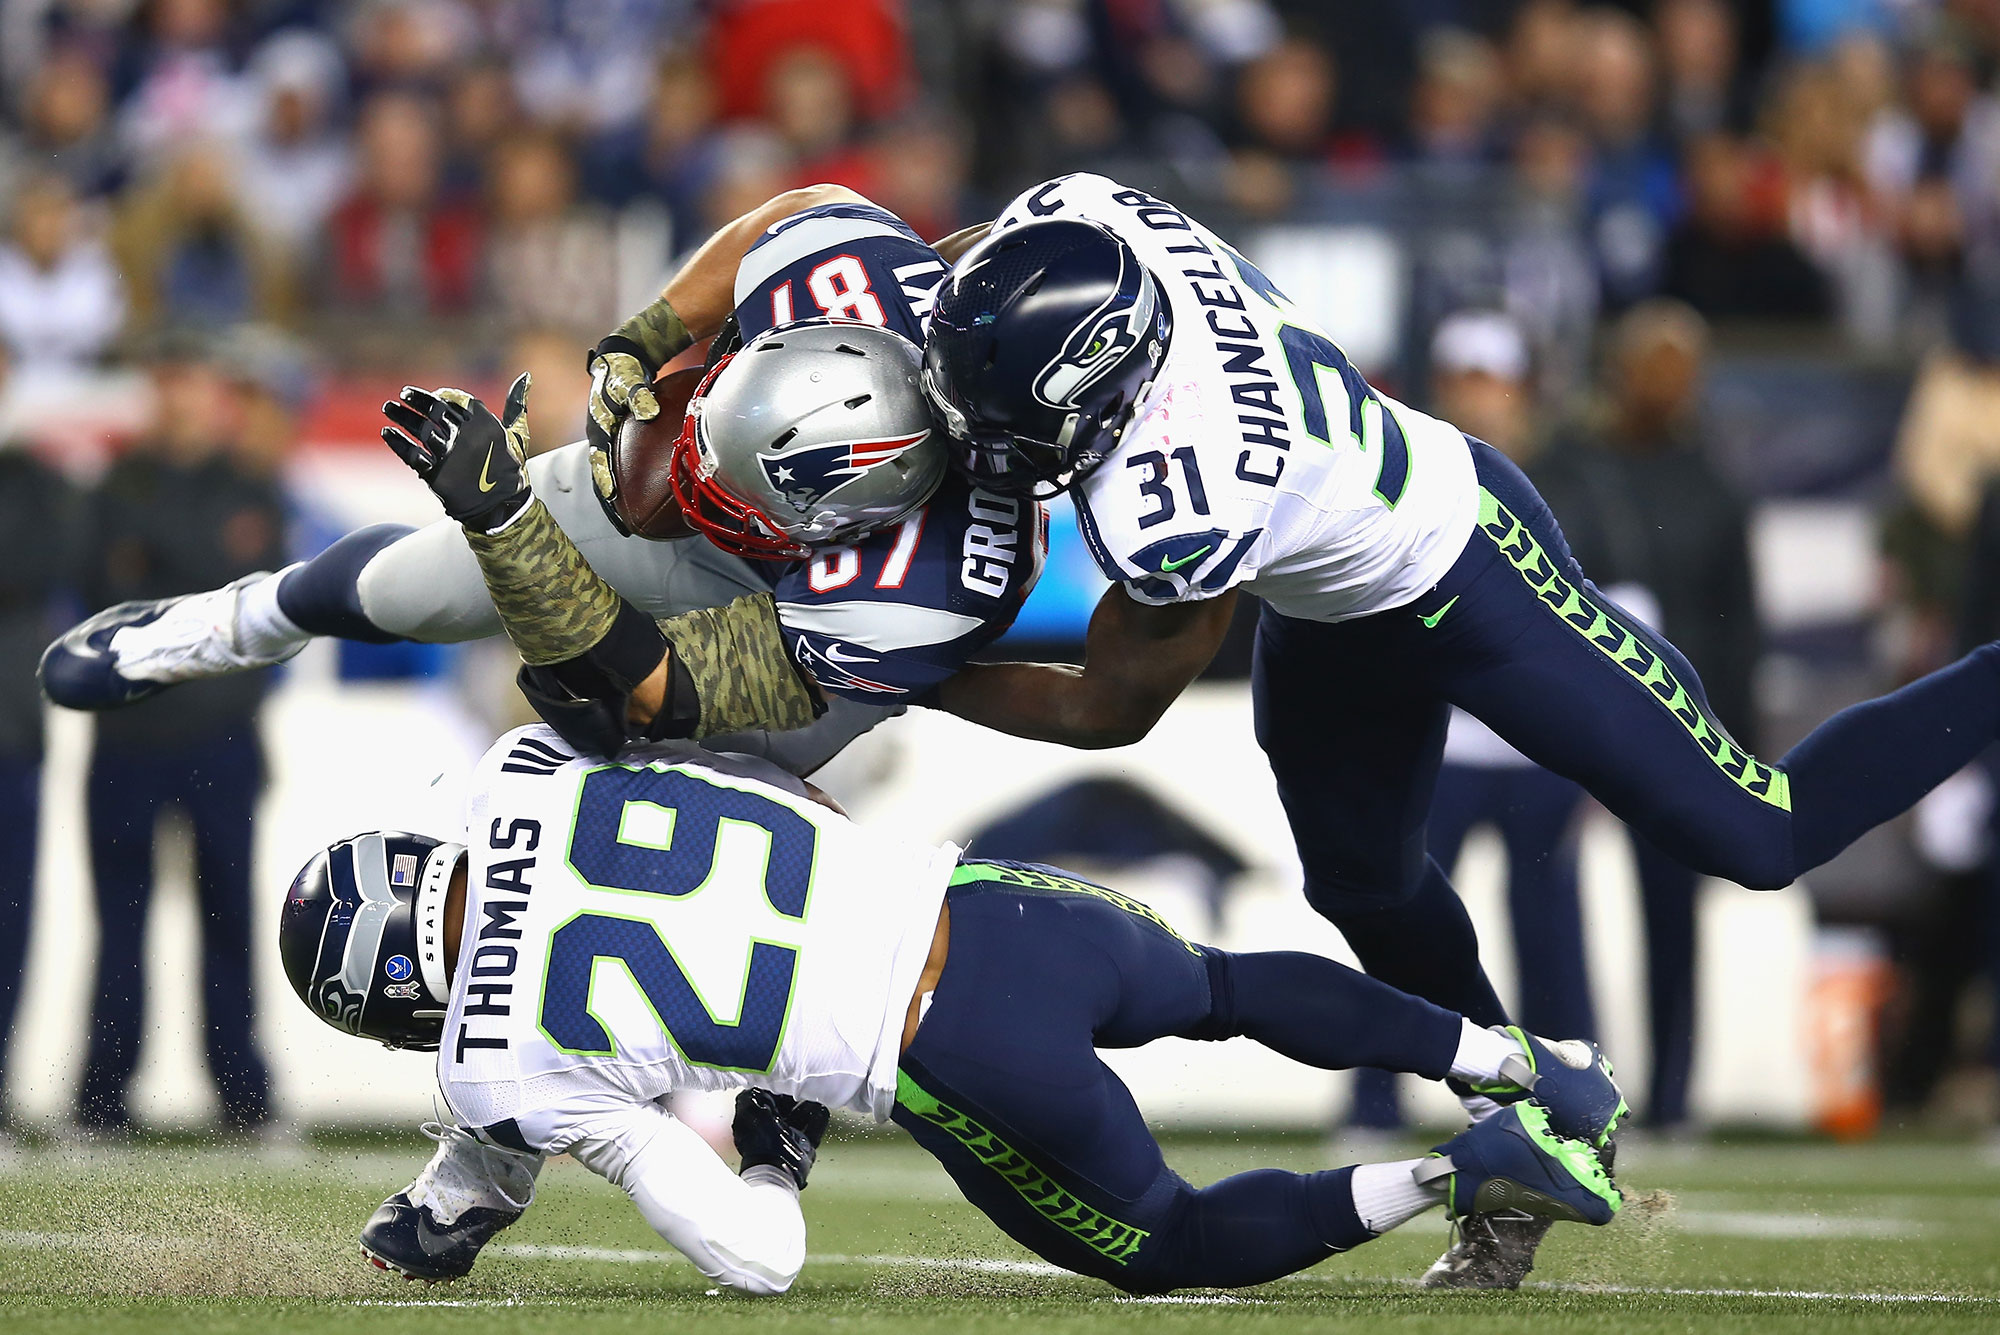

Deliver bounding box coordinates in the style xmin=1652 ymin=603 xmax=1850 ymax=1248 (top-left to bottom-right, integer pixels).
xmin=1778 ymin=644 xmax=2000 ymax=873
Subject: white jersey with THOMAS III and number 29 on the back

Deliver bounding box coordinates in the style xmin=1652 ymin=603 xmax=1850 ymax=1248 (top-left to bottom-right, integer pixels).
xmin=438 ymin=727 xmax=958 ymax=1151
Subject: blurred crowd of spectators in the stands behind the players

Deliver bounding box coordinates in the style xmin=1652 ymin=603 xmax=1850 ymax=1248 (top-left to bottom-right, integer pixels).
xmin=0 ymin=0 xmax=2000 ymax=375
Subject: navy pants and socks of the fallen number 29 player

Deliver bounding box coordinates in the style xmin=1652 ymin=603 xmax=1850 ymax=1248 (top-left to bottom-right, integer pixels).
xmin=894 ymin=861 xmax=1462 ymax=1293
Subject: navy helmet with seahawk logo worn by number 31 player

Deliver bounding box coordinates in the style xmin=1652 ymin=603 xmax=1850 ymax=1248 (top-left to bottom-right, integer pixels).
xmin=924 ymin=218 xmax=1174 ymax=500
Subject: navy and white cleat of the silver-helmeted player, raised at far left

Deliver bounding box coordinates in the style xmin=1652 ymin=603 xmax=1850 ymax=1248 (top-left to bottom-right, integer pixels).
xmin=36 ymin=572 xmax=284 ymax=711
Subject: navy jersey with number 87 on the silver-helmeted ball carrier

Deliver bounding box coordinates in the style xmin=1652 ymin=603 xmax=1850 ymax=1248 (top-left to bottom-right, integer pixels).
xmin=736 ymin=204 xmax=1048 ymax=705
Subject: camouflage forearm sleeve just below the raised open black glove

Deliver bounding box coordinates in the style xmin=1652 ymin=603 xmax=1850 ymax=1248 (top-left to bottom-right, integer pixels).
xmin=466 ymin=500 xmax=620 ymax=668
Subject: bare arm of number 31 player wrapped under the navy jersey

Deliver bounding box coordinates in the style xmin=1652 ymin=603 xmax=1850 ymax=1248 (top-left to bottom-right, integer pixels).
xmin=938 ymin=584 xmax=1236 ymax=749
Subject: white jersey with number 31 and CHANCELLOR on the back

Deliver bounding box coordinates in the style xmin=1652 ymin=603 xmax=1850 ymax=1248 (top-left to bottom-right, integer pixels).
xmin=998 ymin=174 xmax=1478 ymax=622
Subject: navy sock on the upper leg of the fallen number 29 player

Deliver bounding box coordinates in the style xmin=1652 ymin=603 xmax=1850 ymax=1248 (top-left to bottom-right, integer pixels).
xmin=1204 ymin=951 xmax=1464 ymax=1079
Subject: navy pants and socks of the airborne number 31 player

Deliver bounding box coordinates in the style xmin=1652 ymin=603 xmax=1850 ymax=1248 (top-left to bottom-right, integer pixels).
xmin=1254 ymin=442 xmax=2000 ymax=1023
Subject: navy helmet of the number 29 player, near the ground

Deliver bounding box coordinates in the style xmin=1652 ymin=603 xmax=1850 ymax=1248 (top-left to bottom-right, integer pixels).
xmin=278 ymin=829 xmax=466 ymax=1051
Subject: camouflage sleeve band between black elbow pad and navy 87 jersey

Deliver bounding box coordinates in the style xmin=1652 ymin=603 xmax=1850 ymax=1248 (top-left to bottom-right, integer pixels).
xmin=660 ymin=594 xmax=826 ymax=737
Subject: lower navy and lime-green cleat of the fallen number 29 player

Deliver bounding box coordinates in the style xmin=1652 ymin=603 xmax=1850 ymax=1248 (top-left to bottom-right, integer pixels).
xmin=1416 ymin=1103 xmax=1622 ymax=1225
